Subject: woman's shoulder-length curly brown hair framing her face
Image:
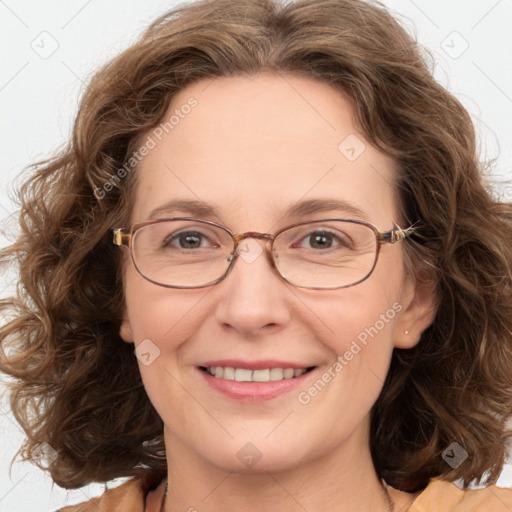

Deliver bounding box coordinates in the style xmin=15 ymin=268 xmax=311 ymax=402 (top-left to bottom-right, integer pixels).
xmin=0 ymin=0 xmax=512 ymax=491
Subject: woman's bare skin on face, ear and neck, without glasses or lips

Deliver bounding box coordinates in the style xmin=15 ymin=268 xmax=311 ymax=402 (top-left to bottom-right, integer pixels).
xmin=120 ymin=74 xmax=435 ymax=512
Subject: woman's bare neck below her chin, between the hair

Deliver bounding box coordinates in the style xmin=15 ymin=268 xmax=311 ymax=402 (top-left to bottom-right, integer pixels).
xmin=165 ymin=428 xmax=396 ymax=512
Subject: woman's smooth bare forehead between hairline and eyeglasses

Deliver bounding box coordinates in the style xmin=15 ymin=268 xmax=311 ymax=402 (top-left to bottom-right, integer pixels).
xmin=132 ymin=74 xmax=397 ymax=230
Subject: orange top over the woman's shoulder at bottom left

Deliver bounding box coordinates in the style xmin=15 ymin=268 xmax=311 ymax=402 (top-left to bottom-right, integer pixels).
xmin=57 ymin=472 xmax=164 ymax=512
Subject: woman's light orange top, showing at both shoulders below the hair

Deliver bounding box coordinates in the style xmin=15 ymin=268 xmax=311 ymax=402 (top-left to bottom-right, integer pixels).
xmin=57 ymin=475 xmax=512 ymax=512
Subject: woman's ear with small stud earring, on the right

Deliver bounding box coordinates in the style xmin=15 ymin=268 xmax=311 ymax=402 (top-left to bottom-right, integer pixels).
xmin=394 ymin=275 xmax=439 ymax=348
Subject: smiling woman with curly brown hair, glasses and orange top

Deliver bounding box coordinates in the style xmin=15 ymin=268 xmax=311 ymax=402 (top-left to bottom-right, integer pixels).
xmin=0 ymin=0 xmax=512 ymax=512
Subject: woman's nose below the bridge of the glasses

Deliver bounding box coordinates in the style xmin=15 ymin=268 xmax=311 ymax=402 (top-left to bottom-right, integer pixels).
xmin=215 ymin=238 xmax=291 ymax=337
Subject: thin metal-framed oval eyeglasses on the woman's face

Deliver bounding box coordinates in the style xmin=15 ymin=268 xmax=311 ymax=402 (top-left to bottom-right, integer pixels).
xmin=113 ymin=217 xmax=414 ymax=290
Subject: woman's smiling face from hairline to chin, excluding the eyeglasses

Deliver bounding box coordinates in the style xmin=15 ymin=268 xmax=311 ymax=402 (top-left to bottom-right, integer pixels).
xmin=121 ymin=74 xmax=432 ymax=472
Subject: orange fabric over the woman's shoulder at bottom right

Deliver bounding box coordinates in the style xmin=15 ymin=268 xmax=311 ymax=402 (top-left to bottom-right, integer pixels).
xmin=409 ymin=479 xmax=512 ymax=512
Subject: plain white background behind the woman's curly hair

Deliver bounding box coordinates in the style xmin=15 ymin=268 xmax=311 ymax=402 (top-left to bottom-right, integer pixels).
xmin=0 ymin=0 xmax=512 ymax=512
